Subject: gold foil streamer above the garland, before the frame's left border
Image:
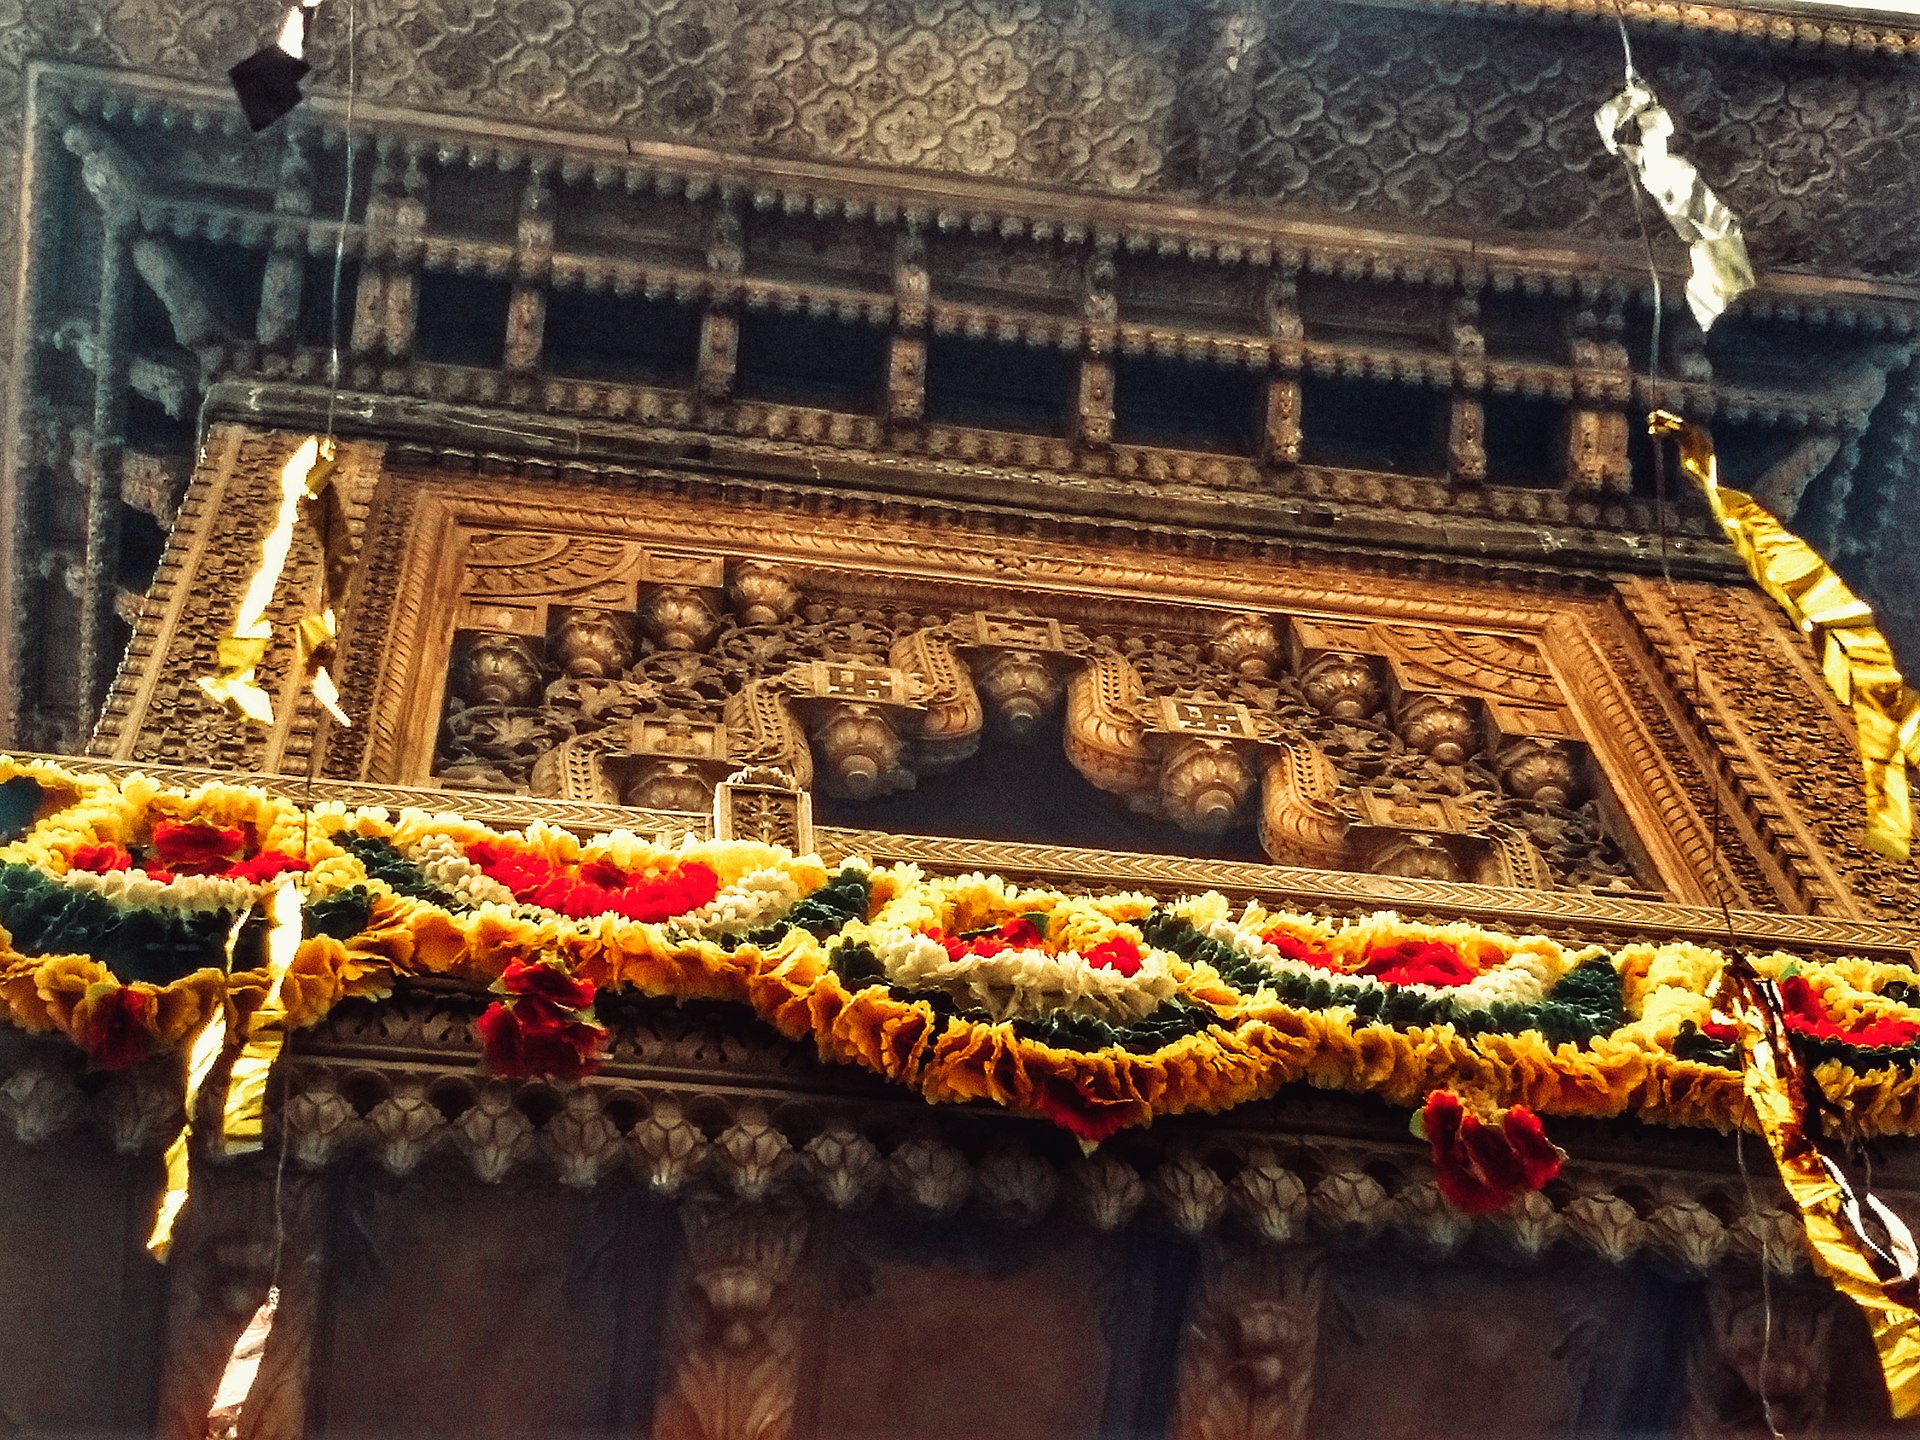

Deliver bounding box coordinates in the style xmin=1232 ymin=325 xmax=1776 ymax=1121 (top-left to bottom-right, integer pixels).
xmin=200 ymin=436 xmax=351 ymax=726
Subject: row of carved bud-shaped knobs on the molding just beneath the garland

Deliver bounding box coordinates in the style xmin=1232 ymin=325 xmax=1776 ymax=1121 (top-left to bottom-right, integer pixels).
xmin=0 ymin=1021 xmax=1889 ymax=1275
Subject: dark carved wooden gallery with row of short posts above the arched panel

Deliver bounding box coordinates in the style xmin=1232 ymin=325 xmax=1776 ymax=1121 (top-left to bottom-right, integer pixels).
xmin=12 ymin=45 xmax=1916 ymax=747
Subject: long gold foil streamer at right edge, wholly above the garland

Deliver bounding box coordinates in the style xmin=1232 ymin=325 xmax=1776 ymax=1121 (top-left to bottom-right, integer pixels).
xmin=1647 ymin=411 xmax=1920 ymax=860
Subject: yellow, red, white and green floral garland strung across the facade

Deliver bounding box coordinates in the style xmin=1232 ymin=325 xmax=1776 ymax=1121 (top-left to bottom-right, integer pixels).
xmin=0 ymin=760 xmax=1920 ymax=1152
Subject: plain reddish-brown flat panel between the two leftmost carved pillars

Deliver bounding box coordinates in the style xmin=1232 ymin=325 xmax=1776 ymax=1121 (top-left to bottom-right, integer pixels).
xmin=311 ymin=1175 xmax=674 ymax=1440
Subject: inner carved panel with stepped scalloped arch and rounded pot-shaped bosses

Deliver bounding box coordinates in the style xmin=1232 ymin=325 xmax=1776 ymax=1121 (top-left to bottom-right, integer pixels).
xmin=318 ymin=458 xmax=1684 ymax=893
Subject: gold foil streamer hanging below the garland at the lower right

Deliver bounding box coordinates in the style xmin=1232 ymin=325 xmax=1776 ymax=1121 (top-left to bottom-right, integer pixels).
xmin=1720 ymin=956 xmax=1920 ymax=1419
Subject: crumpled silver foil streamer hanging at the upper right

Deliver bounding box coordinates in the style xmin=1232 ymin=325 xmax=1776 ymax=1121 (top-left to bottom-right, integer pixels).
xmin=1594 ymin=69 xmax=1753 ymax=330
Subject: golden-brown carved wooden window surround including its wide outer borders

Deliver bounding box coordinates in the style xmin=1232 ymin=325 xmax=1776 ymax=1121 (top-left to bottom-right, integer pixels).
xmin=100 ymin=428 xmax=1908 ymax=916
